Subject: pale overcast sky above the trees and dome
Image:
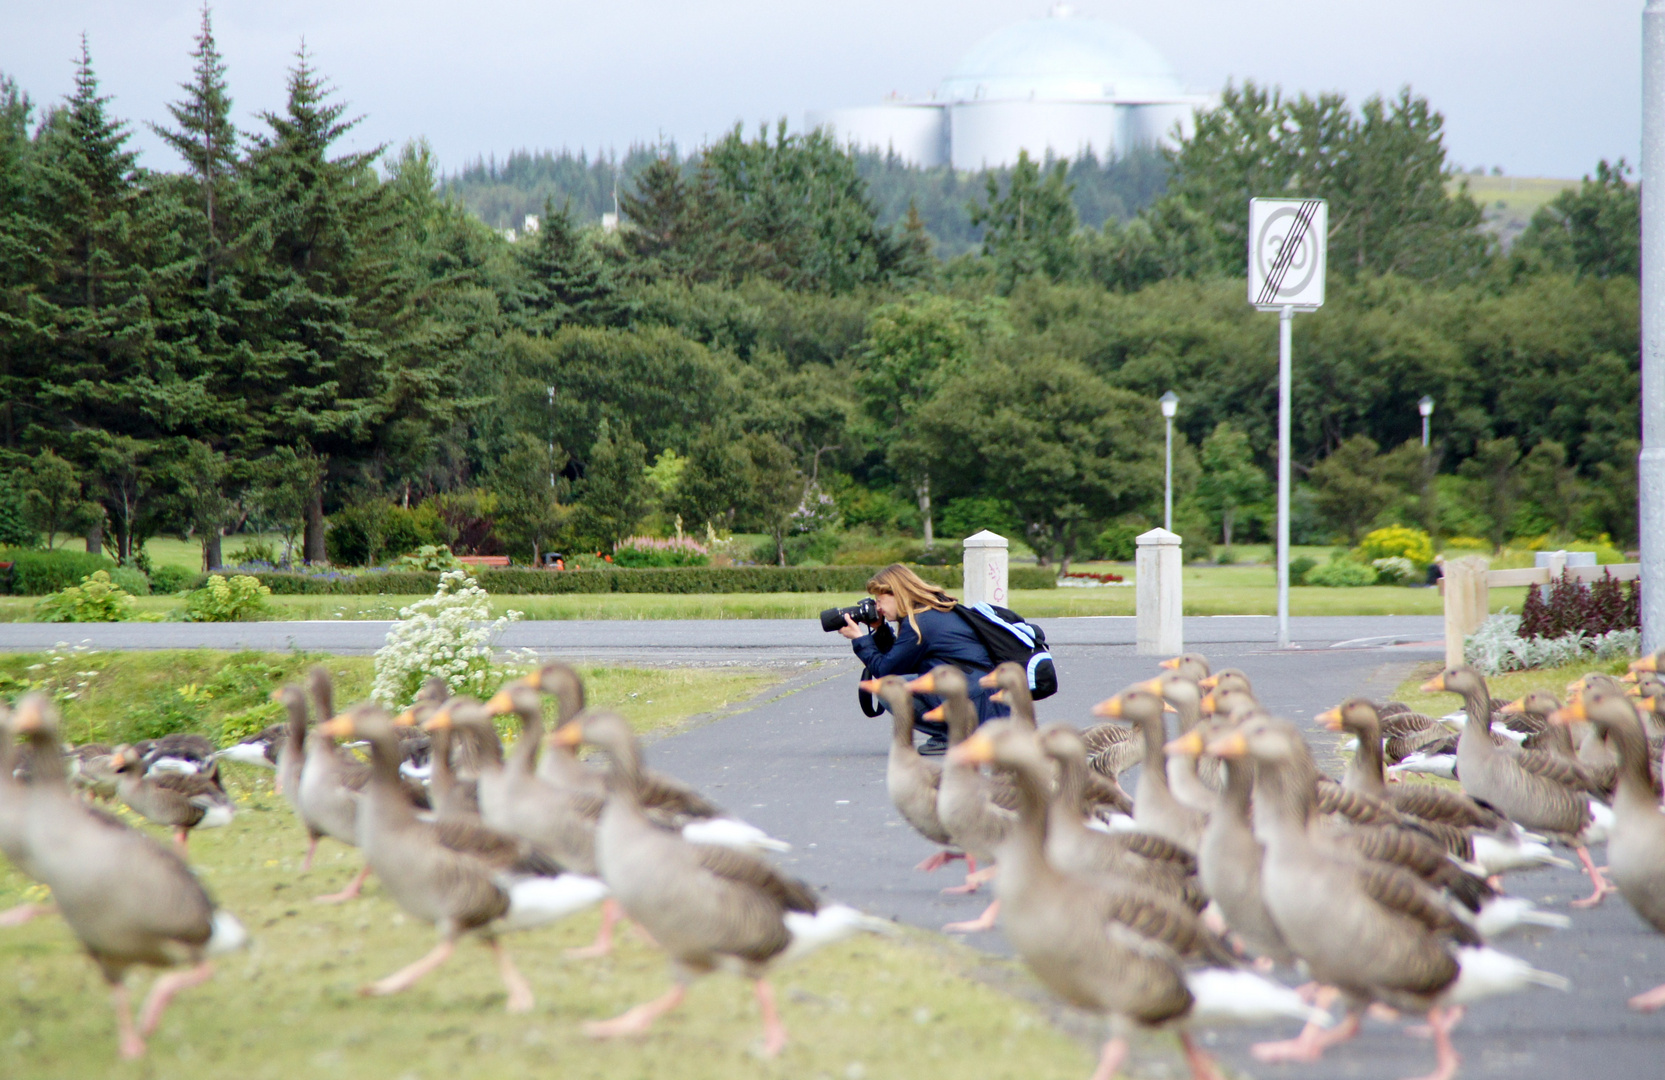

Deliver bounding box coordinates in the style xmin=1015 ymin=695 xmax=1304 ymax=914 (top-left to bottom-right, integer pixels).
xmin=0 ymin=0 xmax=1642 ymax=176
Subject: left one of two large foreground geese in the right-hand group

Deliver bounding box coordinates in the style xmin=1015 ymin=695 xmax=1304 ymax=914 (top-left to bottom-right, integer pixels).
xmin=947 ymin=721 xmax=1327 ymax=1080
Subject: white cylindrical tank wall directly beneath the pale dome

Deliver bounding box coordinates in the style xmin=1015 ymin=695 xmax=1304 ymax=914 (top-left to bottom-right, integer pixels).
xmin=949 ymin=100 xmax=1122 ymax=170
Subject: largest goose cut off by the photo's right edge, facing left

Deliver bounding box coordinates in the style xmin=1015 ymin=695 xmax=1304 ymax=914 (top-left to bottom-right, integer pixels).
xmin=1550 ymin=691 xmax=1665 ymax=1012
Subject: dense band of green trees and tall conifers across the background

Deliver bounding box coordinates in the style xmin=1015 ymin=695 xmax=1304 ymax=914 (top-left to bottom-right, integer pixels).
xmin=0 ymin=12 xmax=1638 ymax=566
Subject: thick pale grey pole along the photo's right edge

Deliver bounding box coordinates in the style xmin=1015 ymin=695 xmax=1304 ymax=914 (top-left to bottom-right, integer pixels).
xmin=1637 ymin=0 xmax=1665 ymax=652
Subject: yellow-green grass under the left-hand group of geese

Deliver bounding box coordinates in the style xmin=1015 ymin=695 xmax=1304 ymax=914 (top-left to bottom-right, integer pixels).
xmin=0 ymin=678 xmax=1092 ymax=1080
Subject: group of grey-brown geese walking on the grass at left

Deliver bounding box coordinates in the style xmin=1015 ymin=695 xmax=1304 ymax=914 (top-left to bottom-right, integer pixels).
xmin=0 ymin=664 xmax=891 ymax=1058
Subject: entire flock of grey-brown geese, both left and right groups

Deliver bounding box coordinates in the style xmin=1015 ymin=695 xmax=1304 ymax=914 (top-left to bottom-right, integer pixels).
xmin=0 ymin=654 xmax=1665 ymax=1080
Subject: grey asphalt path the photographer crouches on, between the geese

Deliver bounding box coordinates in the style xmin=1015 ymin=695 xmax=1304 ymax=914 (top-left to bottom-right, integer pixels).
xmin=629 ymin=621 xmax=1665 ymax=1080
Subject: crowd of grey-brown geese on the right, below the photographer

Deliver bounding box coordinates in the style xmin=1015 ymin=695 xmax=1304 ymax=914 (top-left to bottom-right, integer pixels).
xmin=864 ymin=654 xmax=1665 ymax=1080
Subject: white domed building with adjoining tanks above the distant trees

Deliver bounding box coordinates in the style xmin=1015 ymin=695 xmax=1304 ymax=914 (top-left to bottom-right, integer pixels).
xmin=806 ymin=3 xmax=1214 ymax=170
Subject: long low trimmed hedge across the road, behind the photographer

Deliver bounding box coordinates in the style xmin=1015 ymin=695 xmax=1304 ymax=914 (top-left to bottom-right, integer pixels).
xmin=239 ymin=566 xmax=1057 ymax=596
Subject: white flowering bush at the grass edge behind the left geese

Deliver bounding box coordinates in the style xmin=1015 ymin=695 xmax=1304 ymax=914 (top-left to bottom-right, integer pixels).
xmin=370 ymin=571 xmax=521 ymax=709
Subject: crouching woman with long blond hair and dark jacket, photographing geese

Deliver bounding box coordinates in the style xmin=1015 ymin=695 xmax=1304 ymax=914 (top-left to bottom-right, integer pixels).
xmin=839 ymin=562 xmax=1006 ymax=754
